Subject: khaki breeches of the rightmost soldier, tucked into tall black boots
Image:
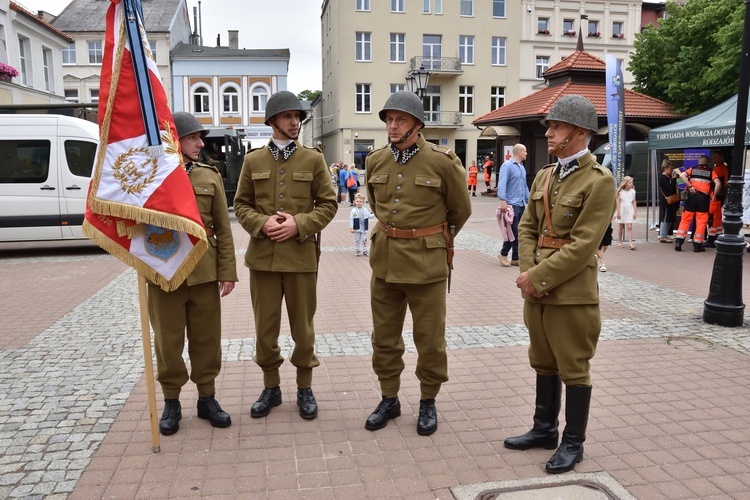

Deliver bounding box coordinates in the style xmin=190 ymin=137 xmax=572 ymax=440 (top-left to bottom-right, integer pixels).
xmin=523 ymin=301 xmax=602 ymax=385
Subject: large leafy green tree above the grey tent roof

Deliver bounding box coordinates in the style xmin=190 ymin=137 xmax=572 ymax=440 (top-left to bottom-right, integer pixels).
xmin=628 ymin=0 xmax=745 ymax=115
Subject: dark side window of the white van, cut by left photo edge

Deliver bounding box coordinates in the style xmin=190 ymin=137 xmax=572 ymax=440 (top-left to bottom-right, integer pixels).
xmin=0 ymin=140 xmax=51 ymax=184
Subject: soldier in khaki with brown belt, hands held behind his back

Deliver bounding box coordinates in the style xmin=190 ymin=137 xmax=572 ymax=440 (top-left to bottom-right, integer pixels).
xmin=365 ymin=91 xmax=471 ymax=436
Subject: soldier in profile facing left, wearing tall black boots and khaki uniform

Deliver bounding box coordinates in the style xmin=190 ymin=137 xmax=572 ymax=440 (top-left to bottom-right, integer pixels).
xmin=505 ymin=95 xmax=616 ymax=473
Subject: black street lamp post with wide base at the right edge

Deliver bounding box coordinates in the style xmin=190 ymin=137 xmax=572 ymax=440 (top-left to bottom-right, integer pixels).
xmin=703 ymin=0 xmax=750 ymax=326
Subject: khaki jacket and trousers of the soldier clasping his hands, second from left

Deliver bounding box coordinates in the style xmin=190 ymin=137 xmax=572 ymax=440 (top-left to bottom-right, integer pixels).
xmin=234 ymin=142 xmax=338 ymax=388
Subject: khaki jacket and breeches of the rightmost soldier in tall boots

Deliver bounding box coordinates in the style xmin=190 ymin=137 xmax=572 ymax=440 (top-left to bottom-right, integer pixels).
xmin=518 ymin=153 xmax=616 ymax=385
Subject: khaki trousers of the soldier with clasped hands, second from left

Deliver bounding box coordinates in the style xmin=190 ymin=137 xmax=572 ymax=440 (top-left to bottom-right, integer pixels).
xmin=250 ymin=269 xmax=320 ymax=389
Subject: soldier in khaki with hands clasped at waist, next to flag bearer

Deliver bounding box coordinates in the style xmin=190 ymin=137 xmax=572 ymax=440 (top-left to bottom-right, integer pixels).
xmin=234 ymin=90 xmax=338 ymax=419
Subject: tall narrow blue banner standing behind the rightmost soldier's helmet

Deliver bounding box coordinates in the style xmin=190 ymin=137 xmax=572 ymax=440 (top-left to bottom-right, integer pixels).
xmin=606 ymin=54 xmax=625 ymax=186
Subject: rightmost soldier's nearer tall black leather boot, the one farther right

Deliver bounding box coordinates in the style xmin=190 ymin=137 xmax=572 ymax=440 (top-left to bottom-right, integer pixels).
xmin=545 ymin=385 xmax=591 ymax=474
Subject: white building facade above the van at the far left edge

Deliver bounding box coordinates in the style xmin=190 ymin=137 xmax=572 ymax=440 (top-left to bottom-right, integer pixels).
xmin=0 ymin=0 xmax=72 ymax=105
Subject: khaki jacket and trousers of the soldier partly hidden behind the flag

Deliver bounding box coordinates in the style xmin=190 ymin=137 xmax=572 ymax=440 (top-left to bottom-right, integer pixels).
xmin=148 ymin=162 xmax=237 ymax=399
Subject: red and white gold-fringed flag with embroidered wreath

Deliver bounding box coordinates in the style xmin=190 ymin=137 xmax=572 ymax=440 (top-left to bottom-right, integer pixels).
xmin=83 ymin=0 xmax=207 ymax=291
